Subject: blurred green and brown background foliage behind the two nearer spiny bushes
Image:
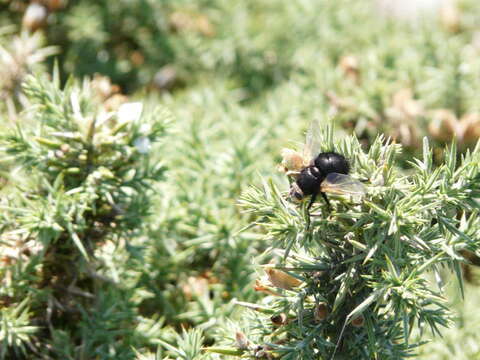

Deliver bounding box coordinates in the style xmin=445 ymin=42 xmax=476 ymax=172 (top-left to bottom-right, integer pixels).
xmin=0 ymin=0 xmax=480 ymax=359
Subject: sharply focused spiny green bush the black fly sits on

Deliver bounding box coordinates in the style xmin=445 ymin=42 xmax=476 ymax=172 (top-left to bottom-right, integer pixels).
xmin=229 ymin=130 xmax=480 ymax=359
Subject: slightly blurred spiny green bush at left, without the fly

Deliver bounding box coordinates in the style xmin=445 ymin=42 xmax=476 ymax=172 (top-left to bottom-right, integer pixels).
xmin=0 ymin=76 xmax=169 ymax=359
